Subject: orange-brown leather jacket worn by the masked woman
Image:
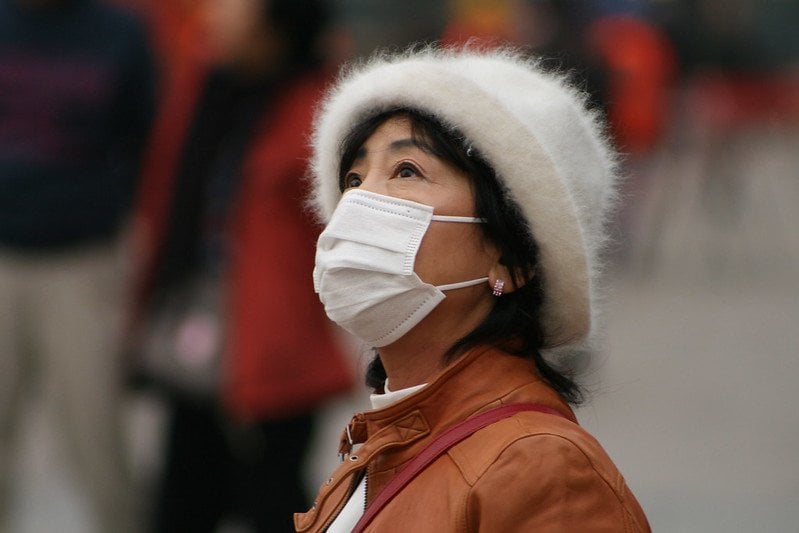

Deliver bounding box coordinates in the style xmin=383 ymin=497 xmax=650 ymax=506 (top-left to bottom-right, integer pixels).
xmin=294 ymin=348 xmax=650 ymax=533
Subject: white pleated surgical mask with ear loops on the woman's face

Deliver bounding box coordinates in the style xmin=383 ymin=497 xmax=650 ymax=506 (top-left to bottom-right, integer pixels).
xmin=314 ymin=189 xmax=488 ymax=347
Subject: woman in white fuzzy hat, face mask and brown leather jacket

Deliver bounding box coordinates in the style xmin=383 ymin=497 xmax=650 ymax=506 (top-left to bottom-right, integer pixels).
xmin=295 ymin=50 xmax=649 ymax=532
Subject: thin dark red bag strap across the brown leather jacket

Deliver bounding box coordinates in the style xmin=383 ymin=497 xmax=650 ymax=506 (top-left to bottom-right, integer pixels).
xmin=352 ymin=403 xmax=565 ymax=533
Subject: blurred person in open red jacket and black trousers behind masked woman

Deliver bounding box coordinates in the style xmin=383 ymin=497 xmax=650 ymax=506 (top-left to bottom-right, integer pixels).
xmin=130 ymin=0 xmax=352 ymax=533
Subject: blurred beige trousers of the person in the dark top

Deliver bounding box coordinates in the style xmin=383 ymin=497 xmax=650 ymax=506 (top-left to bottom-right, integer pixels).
xmin=0 ymin=244 xmax=133 ymax=533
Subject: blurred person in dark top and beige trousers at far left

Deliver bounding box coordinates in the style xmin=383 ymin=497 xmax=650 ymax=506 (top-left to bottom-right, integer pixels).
xmin=0 ymin=0 xmax=153 ymax=532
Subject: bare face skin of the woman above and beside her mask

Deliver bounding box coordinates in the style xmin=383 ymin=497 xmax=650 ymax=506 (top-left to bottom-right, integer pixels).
xmin=344 ymin=116 xmax=498 ymax=290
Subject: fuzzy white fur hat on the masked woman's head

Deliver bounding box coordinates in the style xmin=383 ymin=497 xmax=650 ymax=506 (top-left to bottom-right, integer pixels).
xmin=311 ymin=48 xmax=617 ymax=348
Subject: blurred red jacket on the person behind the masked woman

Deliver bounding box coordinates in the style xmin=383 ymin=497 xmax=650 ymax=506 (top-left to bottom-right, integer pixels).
xmin=134 ymin=57 xmax=353 ymax=420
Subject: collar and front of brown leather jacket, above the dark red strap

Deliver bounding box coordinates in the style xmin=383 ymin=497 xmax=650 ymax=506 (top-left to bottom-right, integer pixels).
xmin=295 ymin=347 xmax=576 ymax=531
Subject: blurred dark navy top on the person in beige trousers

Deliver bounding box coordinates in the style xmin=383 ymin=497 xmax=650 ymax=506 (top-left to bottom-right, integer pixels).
xmin=0 ymin=0 xmax=154 ymax=250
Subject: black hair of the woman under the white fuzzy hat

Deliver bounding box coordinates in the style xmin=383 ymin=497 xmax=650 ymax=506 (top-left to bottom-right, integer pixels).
xmin=339 ymin=107 xmax=584 ymax=405
